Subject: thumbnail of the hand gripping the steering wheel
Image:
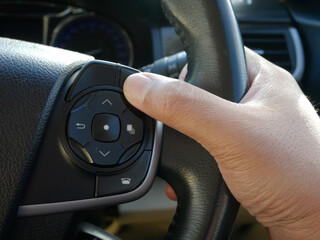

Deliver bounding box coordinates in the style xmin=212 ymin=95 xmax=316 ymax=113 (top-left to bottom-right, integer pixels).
xmin=123 ymin=73 xmax=151 ymax=105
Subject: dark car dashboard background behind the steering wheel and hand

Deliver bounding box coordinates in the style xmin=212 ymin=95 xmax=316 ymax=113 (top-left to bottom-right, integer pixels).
xmin=0 ymin=0 xmax=320 ymax=239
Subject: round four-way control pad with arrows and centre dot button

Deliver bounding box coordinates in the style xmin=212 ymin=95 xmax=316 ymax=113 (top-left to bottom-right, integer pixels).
xmin=67 ymin=89 xmax=148 ymax=167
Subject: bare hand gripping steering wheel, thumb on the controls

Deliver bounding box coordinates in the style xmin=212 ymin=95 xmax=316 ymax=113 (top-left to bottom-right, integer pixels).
xmin=124 ymin=49 xmax=320 ymax=240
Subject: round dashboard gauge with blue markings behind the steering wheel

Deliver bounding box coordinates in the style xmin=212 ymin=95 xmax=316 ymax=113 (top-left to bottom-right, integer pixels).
xmin=51 ymin=15 xmax=133 ymax=66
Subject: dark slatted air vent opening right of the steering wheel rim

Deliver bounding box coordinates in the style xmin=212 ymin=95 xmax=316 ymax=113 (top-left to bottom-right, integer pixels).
xmin=242 ymin=32 xmax=294 ymax=72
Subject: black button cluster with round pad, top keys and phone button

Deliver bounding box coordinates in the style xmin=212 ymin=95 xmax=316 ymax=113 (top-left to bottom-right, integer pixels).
xmin=64 ymin=61 xmax=154 ymax=197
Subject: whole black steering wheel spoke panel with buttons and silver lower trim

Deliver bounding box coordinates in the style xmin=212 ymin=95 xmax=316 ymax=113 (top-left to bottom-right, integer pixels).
xmin=21 ymin=61 xmax=158 ymax=210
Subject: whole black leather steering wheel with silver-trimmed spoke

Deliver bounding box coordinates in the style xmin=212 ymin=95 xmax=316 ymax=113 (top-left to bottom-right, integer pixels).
xmin=0 ymin=0 xmax=247 ymax=240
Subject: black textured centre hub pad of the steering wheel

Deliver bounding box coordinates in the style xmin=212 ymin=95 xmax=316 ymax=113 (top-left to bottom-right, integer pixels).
xmin=0 ymin=38 xmax=92 ymax=239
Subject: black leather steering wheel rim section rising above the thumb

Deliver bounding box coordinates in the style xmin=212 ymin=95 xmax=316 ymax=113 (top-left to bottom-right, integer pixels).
xmin=162 ymin=0 xmax=248 ymax=99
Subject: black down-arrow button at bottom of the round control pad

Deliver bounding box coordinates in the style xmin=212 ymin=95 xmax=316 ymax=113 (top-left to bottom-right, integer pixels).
xmin=85 ymin=141 xmax=125 ymax=166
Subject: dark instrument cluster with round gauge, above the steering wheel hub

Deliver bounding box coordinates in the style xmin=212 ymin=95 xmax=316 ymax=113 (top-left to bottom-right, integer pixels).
xmin=0 ymin=2 xmax=152 ymax=67
